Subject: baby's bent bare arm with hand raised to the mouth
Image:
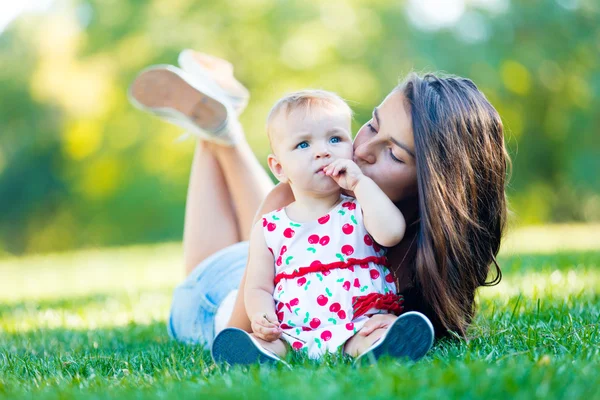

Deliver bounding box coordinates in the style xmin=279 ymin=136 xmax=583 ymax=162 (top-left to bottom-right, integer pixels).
xmin=325 ymin=160 xmax=406 ymax=247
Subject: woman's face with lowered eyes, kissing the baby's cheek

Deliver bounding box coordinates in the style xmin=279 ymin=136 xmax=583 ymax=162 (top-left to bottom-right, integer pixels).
xmin=354 ymin=91 xmax=417 ymax=203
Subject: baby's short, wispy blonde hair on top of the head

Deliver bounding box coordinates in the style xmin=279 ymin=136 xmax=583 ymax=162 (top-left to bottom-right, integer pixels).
xmin=267 ymin=89 xmax=352 ymax=141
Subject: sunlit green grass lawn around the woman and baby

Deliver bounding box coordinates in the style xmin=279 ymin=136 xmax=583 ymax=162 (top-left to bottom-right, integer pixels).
xmin=0 ymin=226 xmax=600 ymax=400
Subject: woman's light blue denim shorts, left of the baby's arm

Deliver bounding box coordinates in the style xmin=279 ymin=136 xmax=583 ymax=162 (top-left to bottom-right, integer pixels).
xmin=167 ymin=242 xmax=248 ymax=345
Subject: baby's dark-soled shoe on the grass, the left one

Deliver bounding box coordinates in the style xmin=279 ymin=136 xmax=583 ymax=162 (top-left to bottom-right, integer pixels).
xmin=210 ymin=328 xmax=290 ymax=368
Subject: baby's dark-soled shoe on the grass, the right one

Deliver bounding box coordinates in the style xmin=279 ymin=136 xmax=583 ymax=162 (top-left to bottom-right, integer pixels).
xmin=354 ymin=311 xmax=434 ymax=365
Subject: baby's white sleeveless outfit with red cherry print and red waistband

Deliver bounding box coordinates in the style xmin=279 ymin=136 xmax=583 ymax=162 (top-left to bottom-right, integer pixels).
xmin=263 ymin=196 xmax=402 ymax=358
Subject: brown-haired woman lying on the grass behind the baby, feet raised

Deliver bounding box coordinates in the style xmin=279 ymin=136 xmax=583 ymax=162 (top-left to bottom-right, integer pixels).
xmin=130 ymin=51 xmax=509 ymax=360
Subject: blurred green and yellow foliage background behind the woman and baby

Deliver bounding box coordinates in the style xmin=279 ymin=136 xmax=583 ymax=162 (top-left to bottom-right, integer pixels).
xmin=0 ymin=0 xmax=600 ymax=256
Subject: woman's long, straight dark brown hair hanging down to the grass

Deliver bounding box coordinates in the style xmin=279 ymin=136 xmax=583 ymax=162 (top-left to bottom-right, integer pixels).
xmin=397 ymin=74 xmax=510 ymax=337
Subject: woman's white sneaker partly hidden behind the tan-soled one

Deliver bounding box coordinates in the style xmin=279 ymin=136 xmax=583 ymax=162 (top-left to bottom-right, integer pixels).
xmin=177 ymin=49 xmax=250 ymax=115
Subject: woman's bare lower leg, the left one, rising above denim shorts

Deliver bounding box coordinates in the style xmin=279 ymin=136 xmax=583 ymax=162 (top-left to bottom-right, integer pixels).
xmin=183 ymin=140 xmax=240 ymax=276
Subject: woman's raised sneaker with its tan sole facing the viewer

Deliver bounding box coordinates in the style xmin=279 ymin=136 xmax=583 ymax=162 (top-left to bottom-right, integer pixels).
xmin=128 ymin=65 xmax=242 ymax=146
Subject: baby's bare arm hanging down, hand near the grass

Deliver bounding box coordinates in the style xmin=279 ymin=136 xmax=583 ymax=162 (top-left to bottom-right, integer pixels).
xmin=244 ymin=222 xmax=281 ymax=342
